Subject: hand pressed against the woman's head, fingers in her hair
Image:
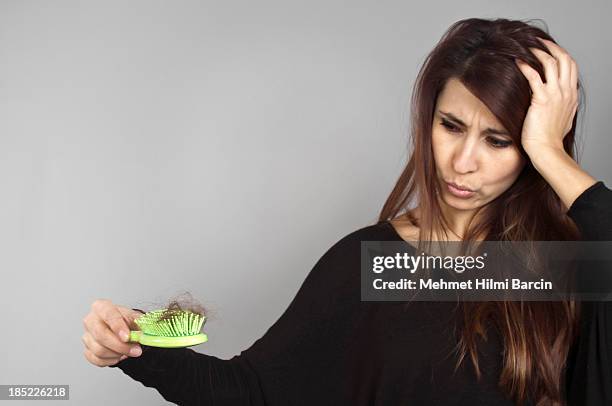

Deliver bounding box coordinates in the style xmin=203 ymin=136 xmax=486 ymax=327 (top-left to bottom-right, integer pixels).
xmin=516 ymin=38 xmax=578 ymax=156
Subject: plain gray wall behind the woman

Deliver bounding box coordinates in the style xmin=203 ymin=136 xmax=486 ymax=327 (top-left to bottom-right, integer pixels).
xmin=0 ymin=0 xmax=612 ymax=405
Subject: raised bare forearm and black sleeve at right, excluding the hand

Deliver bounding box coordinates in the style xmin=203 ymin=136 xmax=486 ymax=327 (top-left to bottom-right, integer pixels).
xmin=526 ymin=99 xmax=612 ymax=406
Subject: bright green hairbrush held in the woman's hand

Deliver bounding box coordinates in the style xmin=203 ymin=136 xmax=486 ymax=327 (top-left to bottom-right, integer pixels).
xmin=129 ymin=309 xmax=208 ymax=348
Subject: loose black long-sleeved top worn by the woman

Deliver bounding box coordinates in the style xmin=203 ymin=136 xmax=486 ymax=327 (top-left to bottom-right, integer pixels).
xmin=113 ymin=181 xmax=612 ymax=406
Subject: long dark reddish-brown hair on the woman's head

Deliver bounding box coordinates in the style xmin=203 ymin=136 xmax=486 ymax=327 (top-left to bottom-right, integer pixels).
xmin=379 ymin=18 xmax=584 ymax=404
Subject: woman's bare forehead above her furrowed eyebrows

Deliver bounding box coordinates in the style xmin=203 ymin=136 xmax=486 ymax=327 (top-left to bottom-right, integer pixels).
xmin=436 ymin=78 xmax=498 ymax=124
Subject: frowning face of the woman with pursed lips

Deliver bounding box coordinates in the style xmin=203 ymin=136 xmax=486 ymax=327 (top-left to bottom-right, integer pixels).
xmin=432 ymin=78 xmax=526 ymax=210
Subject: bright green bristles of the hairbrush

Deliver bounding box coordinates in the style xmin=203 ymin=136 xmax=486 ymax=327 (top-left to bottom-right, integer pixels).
xmin=134 ymin=309 xmax=206 ymax=337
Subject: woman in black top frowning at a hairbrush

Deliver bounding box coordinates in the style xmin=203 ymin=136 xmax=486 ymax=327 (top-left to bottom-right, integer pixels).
xmin=83 ymin=19 xmax=612 ymax=405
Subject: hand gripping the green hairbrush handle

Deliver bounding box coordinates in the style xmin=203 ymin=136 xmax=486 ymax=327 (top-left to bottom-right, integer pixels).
xmin=82 ymin=299 xmax=142 ymax=367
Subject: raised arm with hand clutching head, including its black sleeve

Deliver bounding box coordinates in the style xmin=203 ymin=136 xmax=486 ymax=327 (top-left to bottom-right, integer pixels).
xmin=517 ymin=38 xmax=612 ymax=406
